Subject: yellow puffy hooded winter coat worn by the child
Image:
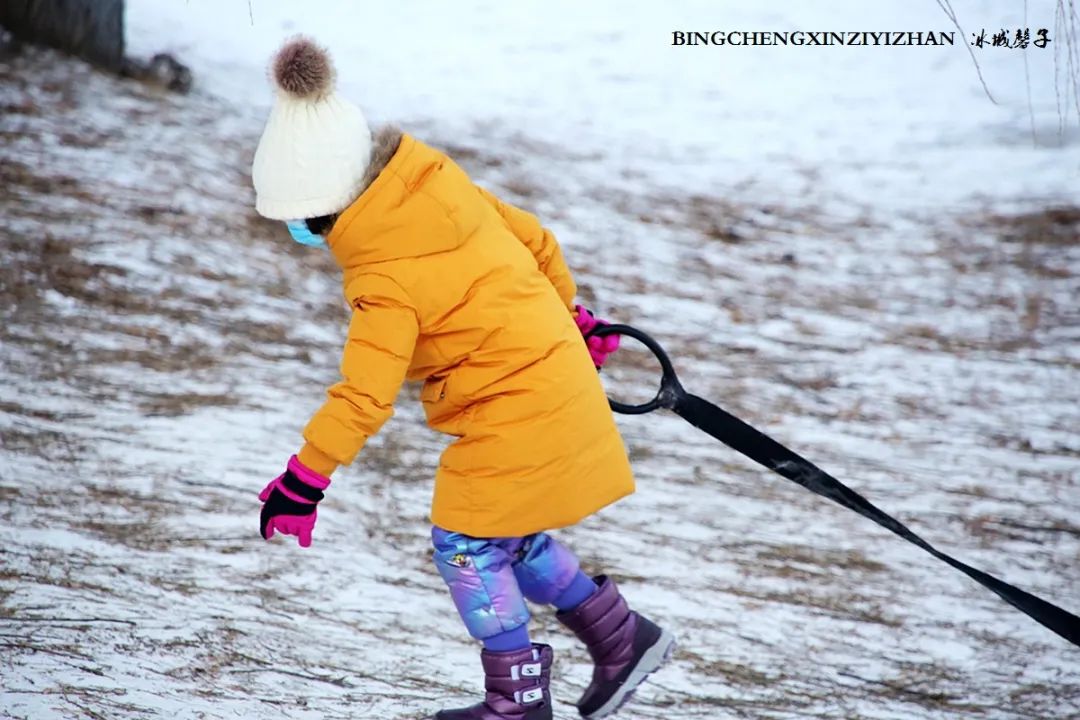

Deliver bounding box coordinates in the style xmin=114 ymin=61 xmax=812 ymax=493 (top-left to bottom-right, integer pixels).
xmin=293 ymin=135 xmax=634 ymax=538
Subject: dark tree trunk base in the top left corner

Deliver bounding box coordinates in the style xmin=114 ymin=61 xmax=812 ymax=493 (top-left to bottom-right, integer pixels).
xmin=0 ymin=0 xmax=124 ymax=71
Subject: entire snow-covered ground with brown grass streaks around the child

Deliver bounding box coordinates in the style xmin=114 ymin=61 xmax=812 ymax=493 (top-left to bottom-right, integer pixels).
xmin=0 ymin=0 xmax=1080 ymax=720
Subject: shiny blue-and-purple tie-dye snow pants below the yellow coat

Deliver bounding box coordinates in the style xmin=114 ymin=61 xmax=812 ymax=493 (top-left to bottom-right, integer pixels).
xmin=431 ymin=527 xmax=579 ymax=640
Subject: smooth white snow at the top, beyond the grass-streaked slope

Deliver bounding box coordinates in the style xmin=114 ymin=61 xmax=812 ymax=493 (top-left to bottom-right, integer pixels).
xmin=122 ymin=0 xmax=1080 ymax=209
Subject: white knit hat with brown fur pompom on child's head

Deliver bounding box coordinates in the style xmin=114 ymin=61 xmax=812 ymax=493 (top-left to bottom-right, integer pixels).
xmin=252 ymin=37 xmax=372 ymax=220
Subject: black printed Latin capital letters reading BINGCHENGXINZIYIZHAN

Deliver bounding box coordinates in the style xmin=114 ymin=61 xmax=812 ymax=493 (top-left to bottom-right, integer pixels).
xmin=672 ymin=30 xmax=956 ymax=46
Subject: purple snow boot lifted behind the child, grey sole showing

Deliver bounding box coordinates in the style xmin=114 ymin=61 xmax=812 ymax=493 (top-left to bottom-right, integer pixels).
xmin=555 ymin=575 xmax=675 ymax=720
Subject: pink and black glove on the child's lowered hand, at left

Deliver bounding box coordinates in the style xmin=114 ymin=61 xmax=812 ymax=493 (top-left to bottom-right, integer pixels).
xmin=259 ymin=456 xmax=330 ymax=547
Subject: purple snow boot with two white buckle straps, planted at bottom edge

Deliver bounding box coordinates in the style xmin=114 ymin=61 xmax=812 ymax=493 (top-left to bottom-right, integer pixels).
xmin=435 ymin=643 xmax=552 ymax=720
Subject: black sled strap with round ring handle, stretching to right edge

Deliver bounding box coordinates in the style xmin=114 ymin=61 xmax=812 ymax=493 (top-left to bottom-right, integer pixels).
xmin=593 ymin=325 xmax=1080 ymax=647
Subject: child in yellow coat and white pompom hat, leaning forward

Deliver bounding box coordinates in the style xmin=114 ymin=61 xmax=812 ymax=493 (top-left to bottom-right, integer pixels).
xmin=253 ymin=38 xmax=675 ymax=720
